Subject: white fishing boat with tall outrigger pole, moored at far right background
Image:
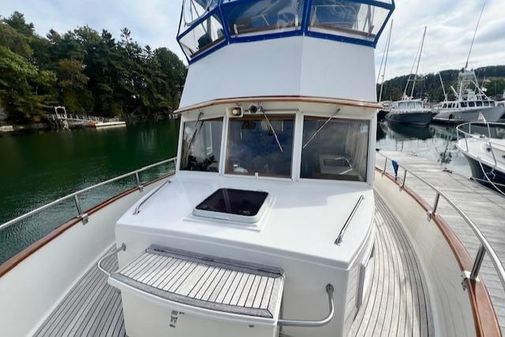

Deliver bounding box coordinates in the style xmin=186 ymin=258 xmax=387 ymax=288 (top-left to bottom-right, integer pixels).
xmin=433 ymin=0 xmax=505 ymax=124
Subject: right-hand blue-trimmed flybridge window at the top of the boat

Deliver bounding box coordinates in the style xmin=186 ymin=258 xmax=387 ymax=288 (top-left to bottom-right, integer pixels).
xmin=310 ymin=0 xmax=389 ymax=41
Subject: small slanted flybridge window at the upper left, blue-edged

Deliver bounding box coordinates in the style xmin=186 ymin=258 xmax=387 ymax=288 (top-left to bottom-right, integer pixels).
xmin=179 ymin=14 xmax=224 ymax=57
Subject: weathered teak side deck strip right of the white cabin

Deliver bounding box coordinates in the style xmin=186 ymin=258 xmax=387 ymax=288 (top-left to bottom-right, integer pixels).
xmin=348 ymin=194 xmax=433 ymax=337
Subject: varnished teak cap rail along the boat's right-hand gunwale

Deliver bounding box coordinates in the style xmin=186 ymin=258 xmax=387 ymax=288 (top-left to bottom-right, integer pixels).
xmin=376 ymin=168 xmax=501 ymax=337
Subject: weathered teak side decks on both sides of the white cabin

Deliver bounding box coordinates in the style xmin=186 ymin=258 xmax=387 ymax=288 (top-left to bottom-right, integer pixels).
xmin=35 ymin=195 xmax=433 ymax=337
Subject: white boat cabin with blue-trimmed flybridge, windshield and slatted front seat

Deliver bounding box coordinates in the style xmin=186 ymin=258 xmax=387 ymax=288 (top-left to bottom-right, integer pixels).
xmin=111 ymin=0 xmax=393 ymax=337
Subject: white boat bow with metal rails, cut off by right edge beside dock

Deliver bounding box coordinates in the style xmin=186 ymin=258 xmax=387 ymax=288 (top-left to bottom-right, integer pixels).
xmin=456 ymin=121 xmax=505 ymax=193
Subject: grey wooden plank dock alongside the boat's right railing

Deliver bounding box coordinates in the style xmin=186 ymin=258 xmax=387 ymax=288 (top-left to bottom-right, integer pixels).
xmin=376 ymin=151 xmax=505 ymax=334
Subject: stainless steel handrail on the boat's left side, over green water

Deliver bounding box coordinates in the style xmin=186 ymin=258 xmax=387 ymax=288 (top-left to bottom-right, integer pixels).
xmin=0 ymin=157 xmax=177 ymax=230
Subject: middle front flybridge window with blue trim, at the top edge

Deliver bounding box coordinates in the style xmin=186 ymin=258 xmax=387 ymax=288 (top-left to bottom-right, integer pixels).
xmin=223 ymin=0 xmax=303 ymax=36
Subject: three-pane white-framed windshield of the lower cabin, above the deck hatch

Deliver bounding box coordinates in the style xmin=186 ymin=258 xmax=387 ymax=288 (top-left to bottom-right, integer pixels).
xmin=176 ymin=109 xmax=373 ymax=183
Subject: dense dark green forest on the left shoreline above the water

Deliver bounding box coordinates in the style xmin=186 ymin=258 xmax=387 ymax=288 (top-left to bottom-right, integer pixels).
xmin=0 ymin=12 xmax=187 ymax=123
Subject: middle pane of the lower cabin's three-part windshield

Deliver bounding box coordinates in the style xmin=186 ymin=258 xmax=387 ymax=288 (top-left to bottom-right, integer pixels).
xmin=225 ymin=114 xmax=295 ymax=178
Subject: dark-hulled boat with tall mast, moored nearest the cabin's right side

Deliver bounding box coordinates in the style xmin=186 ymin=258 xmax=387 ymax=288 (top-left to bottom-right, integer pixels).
xmin=386 ymin=27 xmax=433 ymax=126
